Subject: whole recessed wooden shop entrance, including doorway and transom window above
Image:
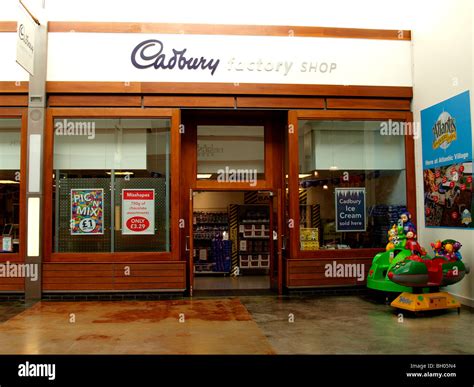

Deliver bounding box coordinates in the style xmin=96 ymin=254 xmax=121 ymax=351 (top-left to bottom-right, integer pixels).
xmin=181 ymin=110 xmax=287 ymax=295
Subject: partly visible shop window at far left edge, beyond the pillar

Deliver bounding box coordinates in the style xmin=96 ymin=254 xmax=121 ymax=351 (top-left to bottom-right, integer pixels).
xmin=0 ymin=118 xmax=21 ymax=253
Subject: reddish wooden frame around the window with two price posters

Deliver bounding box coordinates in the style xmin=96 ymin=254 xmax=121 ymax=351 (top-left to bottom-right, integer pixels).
xmin=43 ymin=108 xmax=181 ymax=262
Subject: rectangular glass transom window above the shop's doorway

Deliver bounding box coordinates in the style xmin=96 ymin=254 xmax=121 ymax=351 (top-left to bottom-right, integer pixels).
xmin=197 ymin=125 xmax=265 ymax=184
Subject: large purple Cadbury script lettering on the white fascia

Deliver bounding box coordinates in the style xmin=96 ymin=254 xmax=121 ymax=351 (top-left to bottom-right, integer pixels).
xmin=131 ymin=39 xmax=220 ymax=75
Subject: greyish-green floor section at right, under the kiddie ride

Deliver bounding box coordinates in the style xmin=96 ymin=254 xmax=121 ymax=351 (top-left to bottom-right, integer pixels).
xmin=241 ymin=296 xmax=474 ymax=354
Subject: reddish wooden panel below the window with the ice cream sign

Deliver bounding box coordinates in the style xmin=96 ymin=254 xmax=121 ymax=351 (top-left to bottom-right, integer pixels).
xmin=286 ymin=257 xmax=373 ymax=288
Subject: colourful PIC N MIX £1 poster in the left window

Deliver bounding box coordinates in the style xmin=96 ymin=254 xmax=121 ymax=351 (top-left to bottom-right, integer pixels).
xmin=71 ymin=188 xmax=104 ymax=235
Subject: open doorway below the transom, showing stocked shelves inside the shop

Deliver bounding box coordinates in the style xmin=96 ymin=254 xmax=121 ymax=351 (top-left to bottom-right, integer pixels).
xmin=189 ymin=190 xmax=284 ymax=294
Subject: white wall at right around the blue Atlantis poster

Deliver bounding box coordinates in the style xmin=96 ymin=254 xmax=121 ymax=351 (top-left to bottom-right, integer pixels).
xmin=412 ymin=0 xmax=474 ymax=306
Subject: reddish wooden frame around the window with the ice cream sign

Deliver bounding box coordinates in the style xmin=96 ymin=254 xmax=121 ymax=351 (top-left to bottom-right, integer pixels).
xmin=288 ymin=110 xmax=416 ymax=259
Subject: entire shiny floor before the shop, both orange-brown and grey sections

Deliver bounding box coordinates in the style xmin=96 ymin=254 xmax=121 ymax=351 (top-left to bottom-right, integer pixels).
xmin=0 ymin=296 xmax=474 ymax=354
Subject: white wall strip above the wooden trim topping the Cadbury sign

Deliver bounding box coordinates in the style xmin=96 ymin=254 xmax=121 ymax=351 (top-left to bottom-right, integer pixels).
xmin=0 ymin=0 xmax=414 ymax=29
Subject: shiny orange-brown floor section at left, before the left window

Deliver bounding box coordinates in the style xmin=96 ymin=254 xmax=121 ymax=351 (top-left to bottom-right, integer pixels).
xmin=0 ymin=299 xmax=273 ymax=354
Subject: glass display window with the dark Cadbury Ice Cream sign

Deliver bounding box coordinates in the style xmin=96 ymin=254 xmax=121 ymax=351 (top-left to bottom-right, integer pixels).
xmin=298 ymin=120 xmax=406 ymax=250
